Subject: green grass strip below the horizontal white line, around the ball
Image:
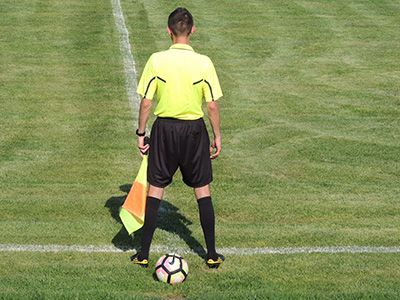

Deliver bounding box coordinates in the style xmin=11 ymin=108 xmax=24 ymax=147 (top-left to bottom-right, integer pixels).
xmin=1 ymin=253 xmax=398 ymax=299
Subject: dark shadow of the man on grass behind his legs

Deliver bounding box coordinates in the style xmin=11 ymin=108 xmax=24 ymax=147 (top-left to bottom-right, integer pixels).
xmin=105 ymin=184 xmax=206 ymax=258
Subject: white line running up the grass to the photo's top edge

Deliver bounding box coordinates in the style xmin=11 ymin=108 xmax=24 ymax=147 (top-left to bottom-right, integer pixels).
xmin=111 ymin=0 xmax=147 ymax=131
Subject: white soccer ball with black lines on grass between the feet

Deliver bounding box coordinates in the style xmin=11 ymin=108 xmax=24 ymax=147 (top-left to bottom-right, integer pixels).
xmin=156 ymin=253 xmax=189 ymax=284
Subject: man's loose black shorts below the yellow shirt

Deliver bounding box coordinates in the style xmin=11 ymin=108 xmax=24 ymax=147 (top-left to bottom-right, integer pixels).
xmin=147 ymin=118 xmax=213 ymax=188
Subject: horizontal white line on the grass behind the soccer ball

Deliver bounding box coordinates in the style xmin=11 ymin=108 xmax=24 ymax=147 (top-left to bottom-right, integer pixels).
xmin=0 ymin=244 xmax=400 ymax=256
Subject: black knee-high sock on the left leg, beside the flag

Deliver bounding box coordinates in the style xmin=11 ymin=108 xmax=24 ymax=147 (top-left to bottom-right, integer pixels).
xmin=138 ymin=196 xmax=161 ymax=260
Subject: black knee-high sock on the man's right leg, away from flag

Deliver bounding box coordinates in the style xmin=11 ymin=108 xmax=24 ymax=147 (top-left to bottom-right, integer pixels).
xmin=197 ymin=197 xmax=218 ymax=260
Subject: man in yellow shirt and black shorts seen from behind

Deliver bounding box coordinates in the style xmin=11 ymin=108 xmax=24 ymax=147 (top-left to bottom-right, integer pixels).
xmin=131 ymin=8 xmax=224 ymax=268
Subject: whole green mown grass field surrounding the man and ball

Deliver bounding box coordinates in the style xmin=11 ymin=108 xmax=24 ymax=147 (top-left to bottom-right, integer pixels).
xmin=0 ymin=0 xmax=400 ymax=299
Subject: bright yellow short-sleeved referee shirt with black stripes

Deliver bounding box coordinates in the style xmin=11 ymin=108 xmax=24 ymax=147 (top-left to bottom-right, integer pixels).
xmin=137 ymin=44 xmax=222 ymax=120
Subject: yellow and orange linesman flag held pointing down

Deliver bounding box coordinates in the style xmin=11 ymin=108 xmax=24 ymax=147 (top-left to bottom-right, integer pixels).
xmin=119 ymin=155 xmax=148 ymax=234
